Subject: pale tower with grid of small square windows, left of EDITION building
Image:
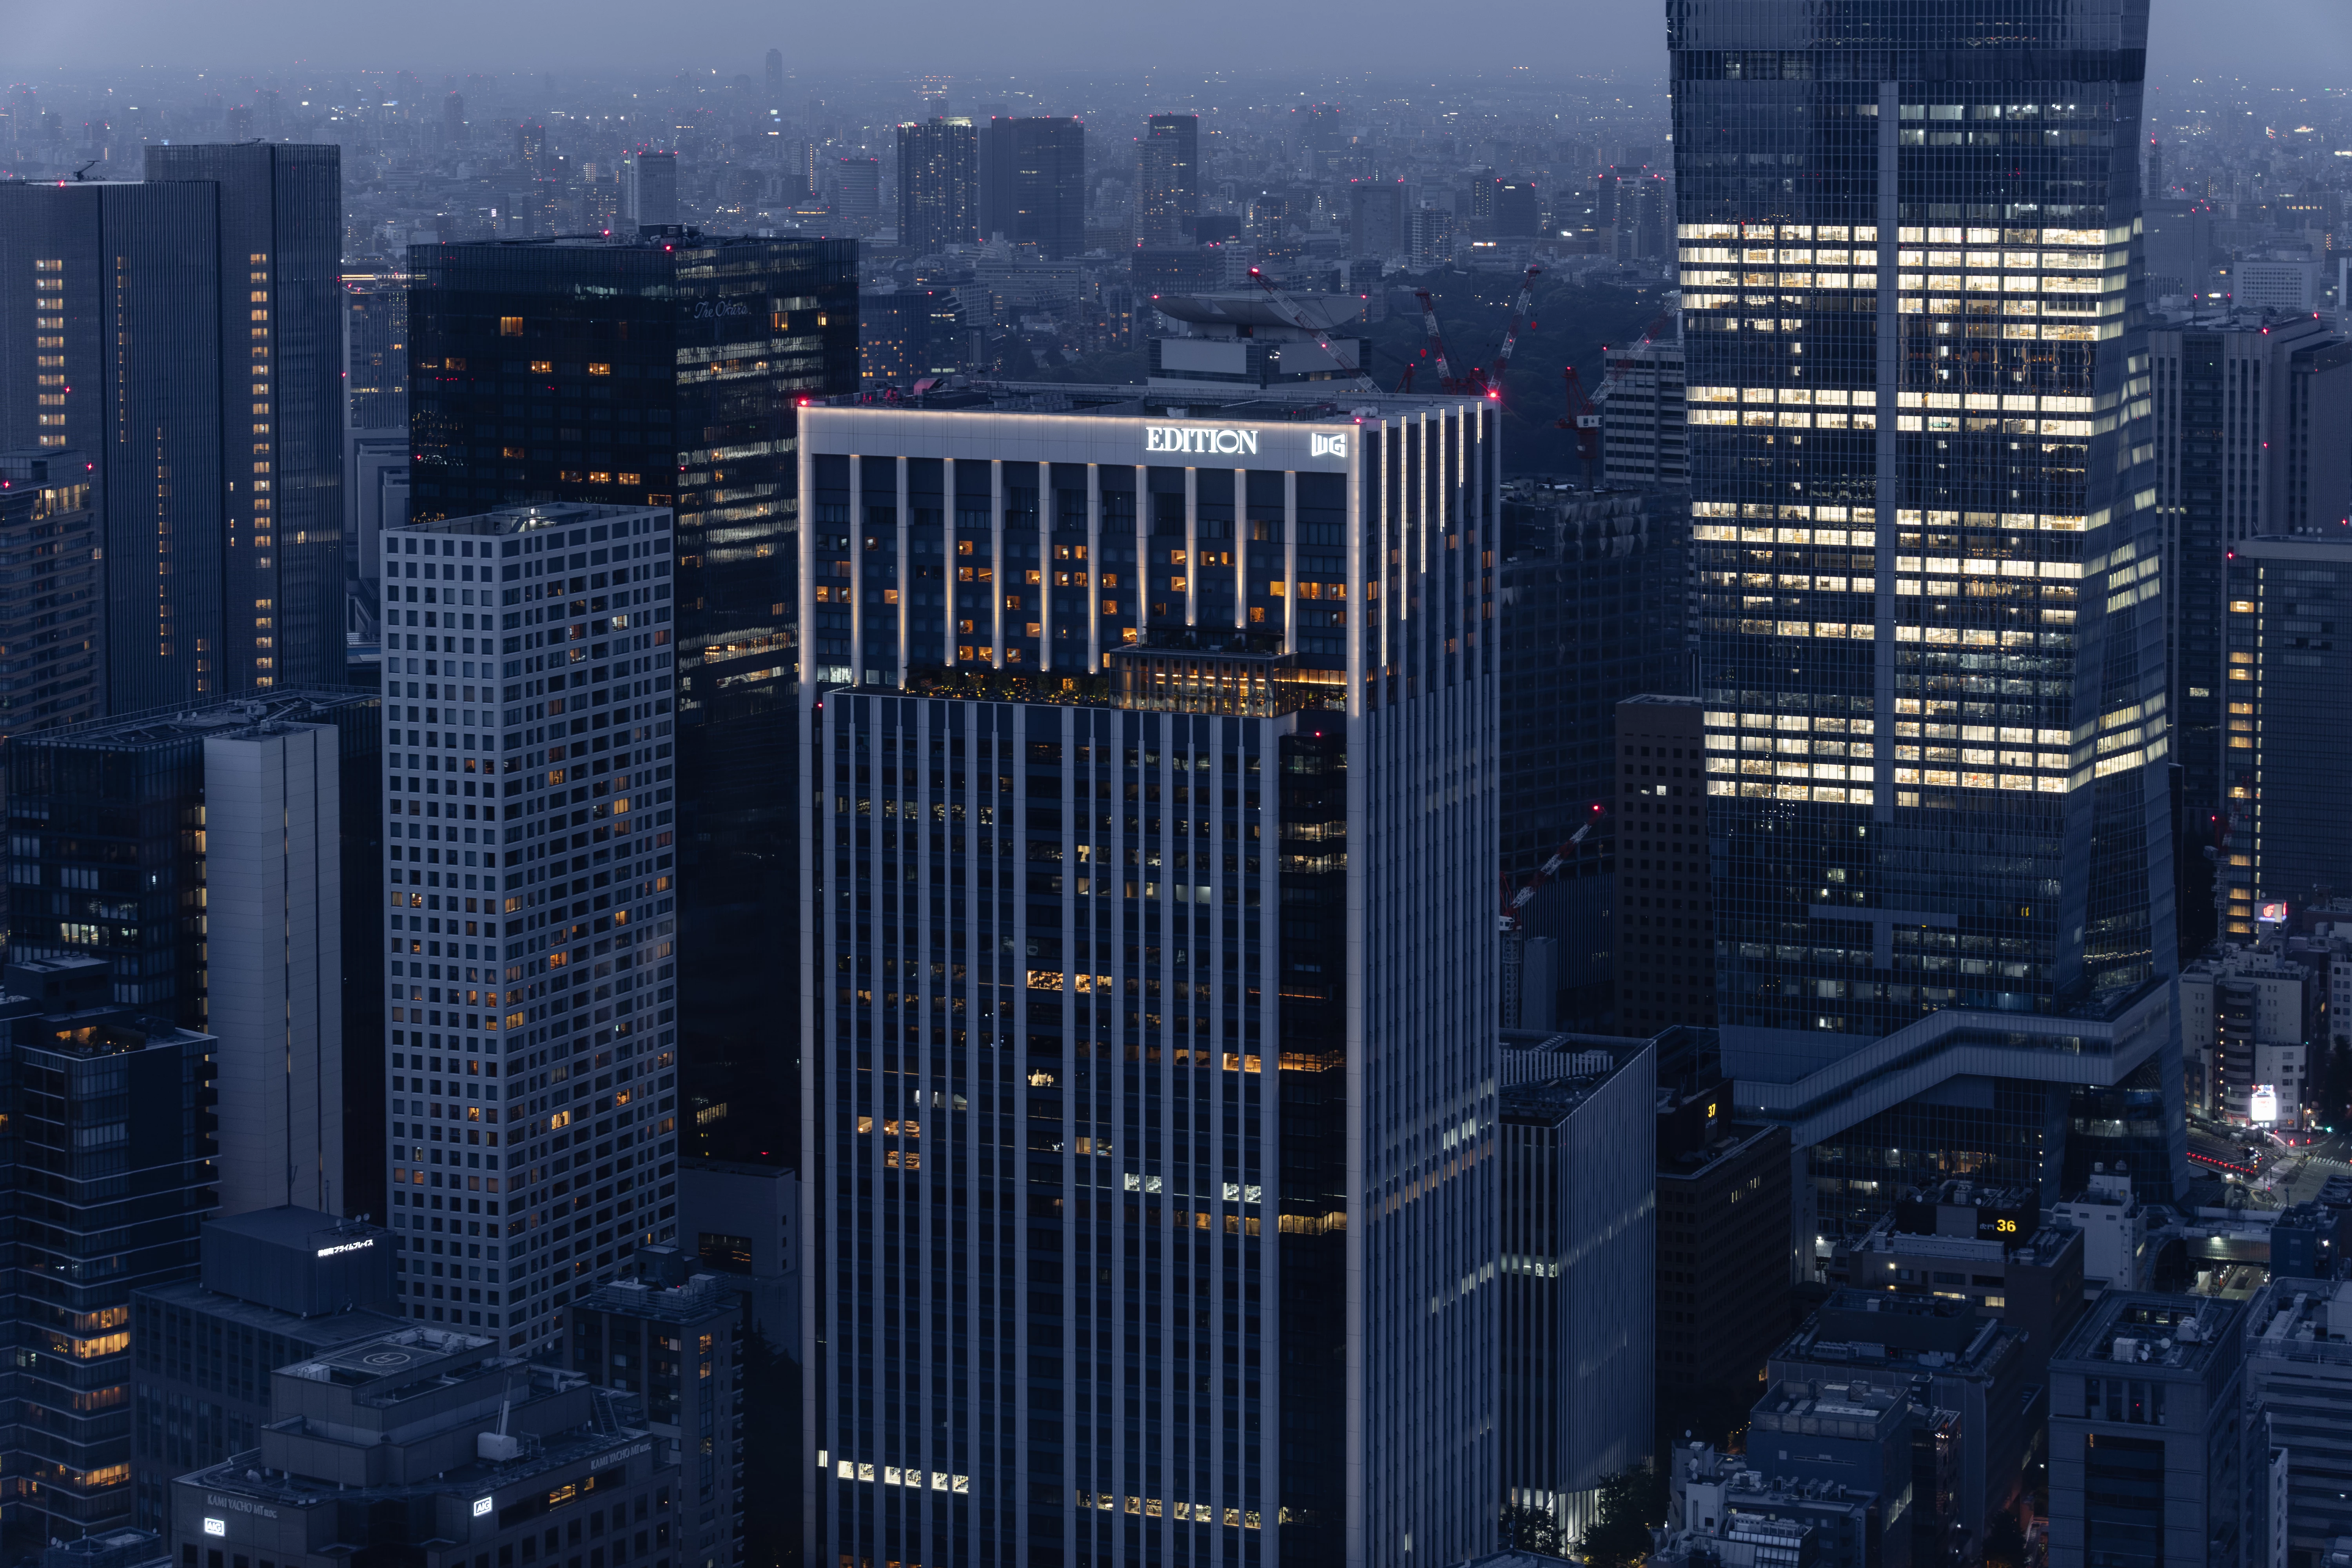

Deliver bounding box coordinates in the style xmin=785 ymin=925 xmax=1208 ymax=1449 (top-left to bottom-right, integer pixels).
xmin=383 ymin=503 xmax=680 ymax=1349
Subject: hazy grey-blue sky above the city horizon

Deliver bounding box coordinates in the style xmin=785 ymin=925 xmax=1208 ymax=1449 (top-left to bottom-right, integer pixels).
xmin=0 ymin=0 xmax=2352 ymax=87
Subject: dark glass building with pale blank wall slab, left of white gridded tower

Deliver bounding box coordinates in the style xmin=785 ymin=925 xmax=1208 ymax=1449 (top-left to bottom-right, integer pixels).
xmin=7 ymin=689 xmax=383 ymax=1213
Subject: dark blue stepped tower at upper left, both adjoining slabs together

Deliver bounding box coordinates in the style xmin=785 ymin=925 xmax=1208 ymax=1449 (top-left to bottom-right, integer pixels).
xmin=0 ymin=156 xmax=343 ymax=712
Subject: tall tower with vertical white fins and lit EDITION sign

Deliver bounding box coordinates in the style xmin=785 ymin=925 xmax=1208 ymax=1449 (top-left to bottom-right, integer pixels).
xmin=800 ymin=388 xmax=1496 ymax=1568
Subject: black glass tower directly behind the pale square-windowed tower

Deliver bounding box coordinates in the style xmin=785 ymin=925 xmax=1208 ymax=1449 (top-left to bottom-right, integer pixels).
xmin=407 ymin=230 xmax=858 ymax=1159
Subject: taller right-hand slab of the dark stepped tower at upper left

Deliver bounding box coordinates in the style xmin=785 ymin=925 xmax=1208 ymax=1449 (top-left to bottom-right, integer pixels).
xmin=143 ymin=141 xmax=343 ymax=701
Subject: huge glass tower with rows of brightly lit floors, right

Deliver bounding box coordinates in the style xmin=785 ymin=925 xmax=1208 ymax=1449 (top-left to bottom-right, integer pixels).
xmin=1668 ymin=0 xmax=2183 ymax=1241
